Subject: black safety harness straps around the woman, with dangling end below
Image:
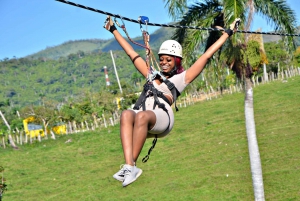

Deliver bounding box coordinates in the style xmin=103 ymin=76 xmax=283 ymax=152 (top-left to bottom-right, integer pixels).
xmin=133 ymin=71 xmax=180 ymax=163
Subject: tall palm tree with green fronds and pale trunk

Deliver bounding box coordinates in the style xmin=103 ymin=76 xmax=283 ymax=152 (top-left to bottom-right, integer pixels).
xmin=164 ymin=0 xmax=296 ymax=200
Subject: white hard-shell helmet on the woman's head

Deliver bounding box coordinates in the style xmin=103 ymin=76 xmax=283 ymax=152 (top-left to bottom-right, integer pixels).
xmin=158 ymin=40 xmax=182 ymax=58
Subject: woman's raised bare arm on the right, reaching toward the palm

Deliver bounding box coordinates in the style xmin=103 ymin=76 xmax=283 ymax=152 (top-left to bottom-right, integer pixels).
xmin=185 ymin=19 xmax=240 ymax=83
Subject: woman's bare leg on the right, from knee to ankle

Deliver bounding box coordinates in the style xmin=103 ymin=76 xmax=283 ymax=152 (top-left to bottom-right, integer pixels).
xmin=132 ymin=110 xmax=156 ymax=162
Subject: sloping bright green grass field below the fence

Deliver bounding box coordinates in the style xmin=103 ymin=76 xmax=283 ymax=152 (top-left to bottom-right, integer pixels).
xmin=0 ymin=77 xmax=300 ymax=201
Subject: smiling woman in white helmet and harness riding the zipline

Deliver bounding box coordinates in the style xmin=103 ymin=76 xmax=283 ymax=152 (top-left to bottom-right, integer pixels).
xmin=104 ymin=16 xmax=240 ymax=187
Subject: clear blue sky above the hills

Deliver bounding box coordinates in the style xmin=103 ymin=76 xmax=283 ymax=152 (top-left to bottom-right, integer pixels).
xmin=0 ymin=0 xmax=300 ymax=59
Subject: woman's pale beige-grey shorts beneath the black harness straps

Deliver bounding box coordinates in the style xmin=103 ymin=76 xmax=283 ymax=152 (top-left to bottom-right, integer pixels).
xmin=133 ymin=97 xmax=174 ymax=138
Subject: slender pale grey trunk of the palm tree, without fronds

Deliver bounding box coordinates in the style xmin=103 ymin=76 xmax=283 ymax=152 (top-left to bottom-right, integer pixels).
xmin=245 ymin=78 xmax=265 ymax=201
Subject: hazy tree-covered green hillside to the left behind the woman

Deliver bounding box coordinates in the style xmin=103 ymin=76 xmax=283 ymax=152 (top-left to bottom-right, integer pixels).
xmin=0 ymin=28 xmax=299 ymax=107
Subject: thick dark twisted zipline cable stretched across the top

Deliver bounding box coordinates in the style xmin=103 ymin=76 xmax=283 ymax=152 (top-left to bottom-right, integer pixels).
xmin=56 ymin=0 xmax=300 ymax=37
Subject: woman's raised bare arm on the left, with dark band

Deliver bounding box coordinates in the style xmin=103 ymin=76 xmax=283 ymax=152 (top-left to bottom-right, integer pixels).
xmin=104 ymin=16 xmax=148 ymax=77
